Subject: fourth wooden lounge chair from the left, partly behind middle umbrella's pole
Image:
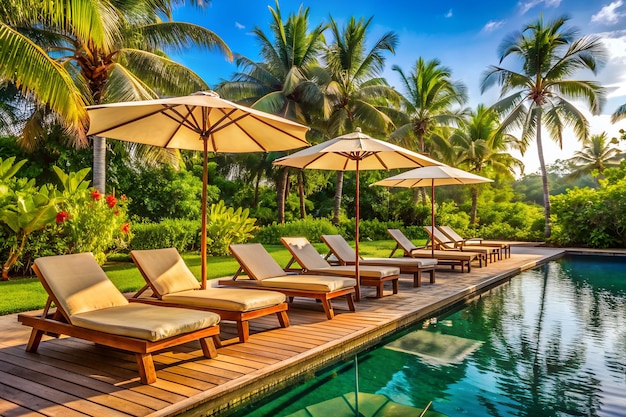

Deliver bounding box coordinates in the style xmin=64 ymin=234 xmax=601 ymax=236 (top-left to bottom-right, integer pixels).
xmin=280 ymin=237 xmax=400 ymax=301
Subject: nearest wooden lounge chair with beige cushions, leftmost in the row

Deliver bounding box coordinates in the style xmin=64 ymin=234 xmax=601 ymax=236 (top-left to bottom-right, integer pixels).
xmin=18 ymin=253 xmax=220 ymax=384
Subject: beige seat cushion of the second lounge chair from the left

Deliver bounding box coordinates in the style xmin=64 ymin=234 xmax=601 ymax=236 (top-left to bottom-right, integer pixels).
xmin=162 ymin=288 xmax=286 ymax=312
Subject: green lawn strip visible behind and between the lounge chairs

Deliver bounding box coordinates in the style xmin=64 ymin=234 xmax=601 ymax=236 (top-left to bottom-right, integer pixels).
xmin=0 ymin=240 xmax=410 ymax=315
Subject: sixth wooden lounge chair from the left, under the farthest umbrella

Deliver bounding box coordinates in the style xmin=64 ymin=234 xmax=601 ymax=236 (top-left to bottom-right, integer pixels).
xmin=387 ymin=229 xmax=484 ymax=272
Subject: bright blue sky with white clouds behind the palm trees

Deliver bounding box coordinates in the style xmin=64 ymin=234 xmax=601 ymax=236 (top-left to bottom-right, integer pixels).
xmin=174 ymin=0 xmax=626 ymax=173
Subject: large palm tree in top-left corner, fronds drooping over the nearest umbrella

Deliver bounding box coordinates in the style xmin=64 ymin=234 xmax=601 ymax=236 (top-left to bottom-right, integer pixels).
xmin=0 ymin=0 xmax=232 ymax=191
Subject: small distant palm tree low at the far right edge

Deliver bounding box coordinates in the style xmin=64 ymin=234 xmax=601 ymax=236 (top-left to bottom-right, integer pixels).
xmin=569 ymin=132 xmax=624 ymax=179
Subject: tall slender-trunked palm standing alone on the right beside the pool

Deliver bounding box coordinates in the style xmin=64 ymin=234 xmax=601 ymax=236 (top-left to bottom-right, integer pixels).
xmin=482 ymin=17 xmax=606 ymax=238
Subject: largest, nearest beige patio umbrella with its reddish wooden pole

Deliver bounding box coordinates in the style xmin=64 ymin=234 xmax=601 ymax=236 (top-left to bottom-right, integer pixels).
xmin=87 ymin=91 xmax=309 ymax=288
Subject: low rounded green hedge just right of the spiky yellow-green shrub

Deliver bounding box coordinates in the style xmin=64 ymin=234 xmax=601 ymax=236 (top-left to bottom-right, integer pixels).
xmin=254 ymin=218 xmax=339 ymax=245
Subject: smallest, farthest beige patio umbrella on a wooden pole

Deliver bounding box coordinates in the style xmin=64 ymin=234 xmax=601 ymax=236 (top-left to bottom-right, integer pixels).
xmin=372 ymin=165 xmax=493 ymax=258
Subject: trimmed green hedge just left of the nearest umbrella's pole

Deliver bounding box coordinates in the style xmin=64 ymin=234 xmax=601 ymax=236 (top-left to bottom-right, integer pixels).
xmin=130 ymin=219 xmax=201 ymax=252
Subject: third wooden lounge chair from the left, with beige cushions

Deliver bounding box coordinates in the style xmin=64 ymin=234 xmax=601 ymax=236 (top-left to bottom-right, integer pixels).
xmin=219 ymin=243 xmax=356 ymax=320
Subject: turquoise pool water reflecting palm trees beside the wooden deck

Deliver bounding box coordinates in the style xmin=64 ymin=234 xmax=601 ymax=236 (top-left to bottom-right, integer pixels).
xmin=227 ymin=256 xmax=626 ymax=417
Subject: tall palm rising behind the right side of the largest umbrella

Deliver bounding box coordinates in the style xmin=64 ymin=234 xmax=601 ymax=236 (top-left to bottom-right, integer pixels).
xmin=218 ymin=2 xmax=328 ymax=223
